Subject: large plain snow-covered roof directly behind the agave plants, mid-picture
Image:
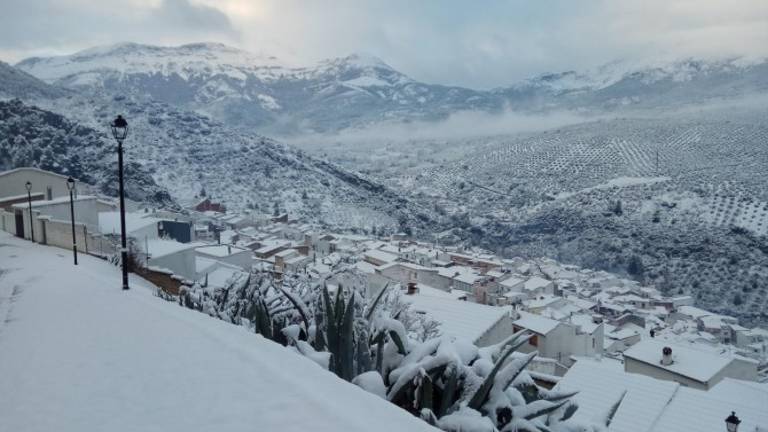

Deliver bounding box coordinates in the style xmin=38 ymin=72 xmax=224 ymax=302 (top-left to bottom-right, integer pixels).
xmin=403 ymin=294 xmax=510 ymax=342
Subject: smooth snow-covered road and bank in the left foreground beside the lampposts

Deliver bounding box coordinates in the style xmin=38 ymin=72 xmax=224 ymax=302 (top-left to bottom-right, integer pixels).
xmin=0 ymin=232 xmax=434 ymax=432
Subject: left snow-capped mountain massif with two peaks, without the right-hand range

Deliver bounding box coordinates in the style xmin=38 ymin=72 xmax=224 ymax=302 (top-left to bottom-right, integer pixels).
xmin=17 ymin=43 xmax=500 ymax=133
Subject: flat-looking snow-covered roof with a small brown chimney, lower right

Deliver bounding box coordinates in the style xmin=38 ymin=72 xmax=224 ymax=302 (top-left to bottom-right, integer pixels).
xmin=624 ymin=339 xmax=733 ymax=383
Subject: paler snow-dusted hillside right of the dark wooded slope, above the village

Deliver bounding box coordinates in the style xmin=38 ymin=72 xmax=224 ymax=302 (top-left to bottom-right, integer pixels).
xmin=39 ymin=94 xmax=434 ymax=230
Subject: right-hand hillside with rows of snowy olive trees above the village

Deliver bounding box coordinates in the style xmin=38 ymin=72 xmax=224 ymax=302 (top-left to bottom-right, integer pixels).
xmin=380 ymin=112 xmax=768 ymax=323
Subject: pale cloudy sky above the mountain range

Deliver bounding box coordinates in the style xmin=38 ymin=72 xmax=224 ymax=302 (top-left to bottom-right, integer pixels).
xmin=0 ymin=0 xmax=768 ymax=88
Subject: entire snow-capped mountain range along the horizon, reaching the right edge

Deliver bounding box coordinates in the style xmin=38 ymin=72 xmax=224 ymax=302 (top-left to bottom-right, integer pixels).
xmin=12 ymin=43 xmax=768 ymax=135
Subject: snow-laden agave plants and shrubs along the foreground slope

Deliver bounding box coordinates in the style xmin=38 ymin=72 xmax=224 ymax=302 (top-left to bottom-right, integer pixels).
xmin=174 ymin=269 xmax=600 ymax=432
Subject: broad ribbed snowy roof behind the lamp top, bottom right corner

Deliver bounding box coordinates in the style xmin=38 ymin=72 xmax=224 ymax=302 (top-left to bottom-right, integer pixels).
xmin=554 ymin=359 xmax=768 ymax=432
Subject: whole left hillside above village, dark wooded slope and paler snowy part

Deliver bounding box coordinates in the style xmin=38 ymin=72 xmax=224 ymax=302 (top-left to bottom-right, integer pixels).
xmin=0 ymin=62 xmax=434 ymax=231
